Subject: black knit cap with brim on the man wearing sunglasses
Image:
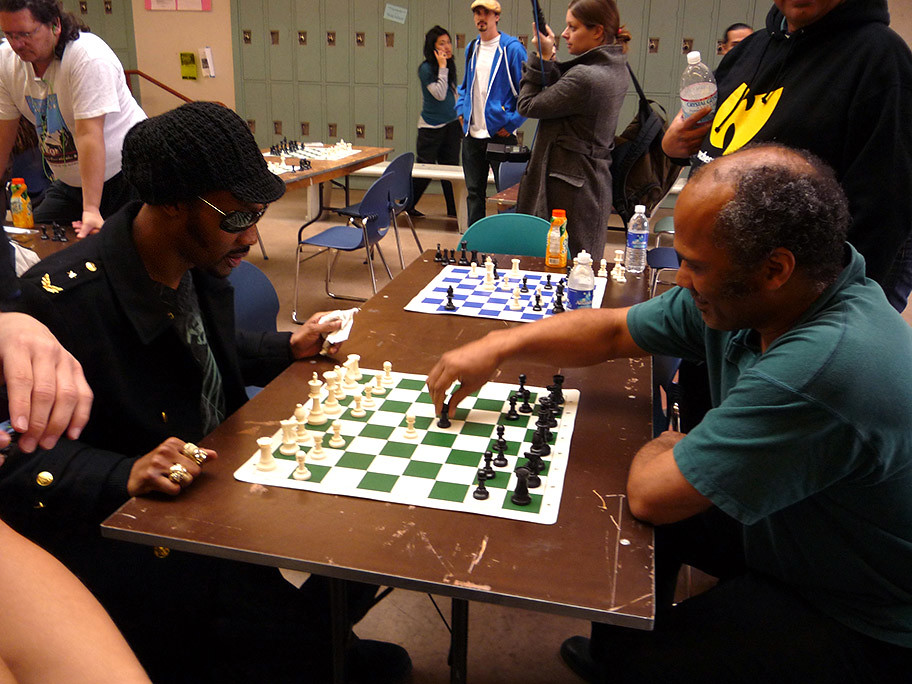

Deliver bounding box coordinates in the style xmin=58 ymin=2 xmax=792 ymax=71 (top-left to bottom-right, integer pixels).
xmin=121 ymin=102 xmax=285 ymax=205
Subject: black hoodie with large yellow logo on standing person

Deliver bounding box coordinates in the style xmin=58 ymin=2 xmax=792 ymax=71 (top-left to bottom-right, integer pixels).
xmin=697 ymin=0 xmax=912 ymax=284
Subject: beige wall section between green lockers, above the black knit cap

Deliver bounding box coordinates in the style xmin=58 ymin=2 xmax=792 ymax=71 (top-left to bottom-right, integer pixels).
xmin=131 ymin=0 xmax=234 ymax=116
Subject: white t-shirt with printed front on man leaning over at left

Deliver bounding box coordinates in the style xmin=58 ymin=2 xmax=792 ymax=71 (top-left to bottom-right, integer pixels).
xmin=0 ymin=33 xmax=146 ymax=187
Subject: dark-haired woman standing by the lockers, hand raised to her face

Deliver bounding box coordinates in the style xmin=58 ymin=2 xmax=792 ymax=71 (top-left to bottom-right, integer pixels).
xmin=410 ymin=26 xmax=462 ymax=216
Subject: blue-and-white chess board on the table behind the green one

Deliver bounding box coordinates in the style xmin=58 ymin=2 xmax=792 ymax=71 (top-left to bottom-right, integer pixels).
xmin=405 ymin=265 xmax=607 ymax=321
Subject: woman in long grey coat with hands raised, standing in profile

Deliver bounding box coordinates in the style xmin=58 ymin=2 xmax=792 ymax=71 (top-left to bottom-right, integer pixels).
xmin=516 ymin=0 xmax=630 ymax=263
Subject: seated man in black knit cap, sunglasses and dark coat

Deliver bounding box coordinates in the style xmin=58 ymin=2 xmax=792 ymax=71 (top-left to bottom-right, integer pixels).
xmin=0 ymin=102 xmax=411 ymax=683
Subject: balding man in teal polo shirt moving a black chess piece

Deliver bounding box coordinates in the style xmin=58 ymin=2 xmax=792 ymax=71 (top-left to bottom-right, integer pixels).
xmin=428 ymin=145 xmax=912 ymax=682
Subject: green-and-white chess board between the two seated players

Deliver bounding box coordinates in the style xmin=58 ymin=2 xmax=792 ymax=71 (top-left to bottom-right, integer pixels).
xmin=234 ymin=370 xmax=579 ymax=525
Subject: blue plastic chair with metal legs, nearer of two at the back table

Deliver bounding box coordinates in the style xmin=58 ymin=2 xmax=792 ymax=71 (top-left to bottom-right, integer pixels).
xmin=292 ymin=174 xmax=393 ymax=314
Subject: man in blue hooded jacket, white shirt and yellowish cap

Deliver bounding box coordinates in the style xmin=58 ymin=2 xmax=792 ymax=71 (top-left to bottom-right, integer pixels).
xmin=456 ymin=0 xmax=526 ymax=230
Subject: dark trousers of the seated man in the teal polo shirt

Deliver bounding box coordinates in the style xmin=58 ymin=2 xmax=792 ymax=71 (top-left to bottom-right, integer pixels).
xmin=591 ymin=509 xmax=912 ymax=684
